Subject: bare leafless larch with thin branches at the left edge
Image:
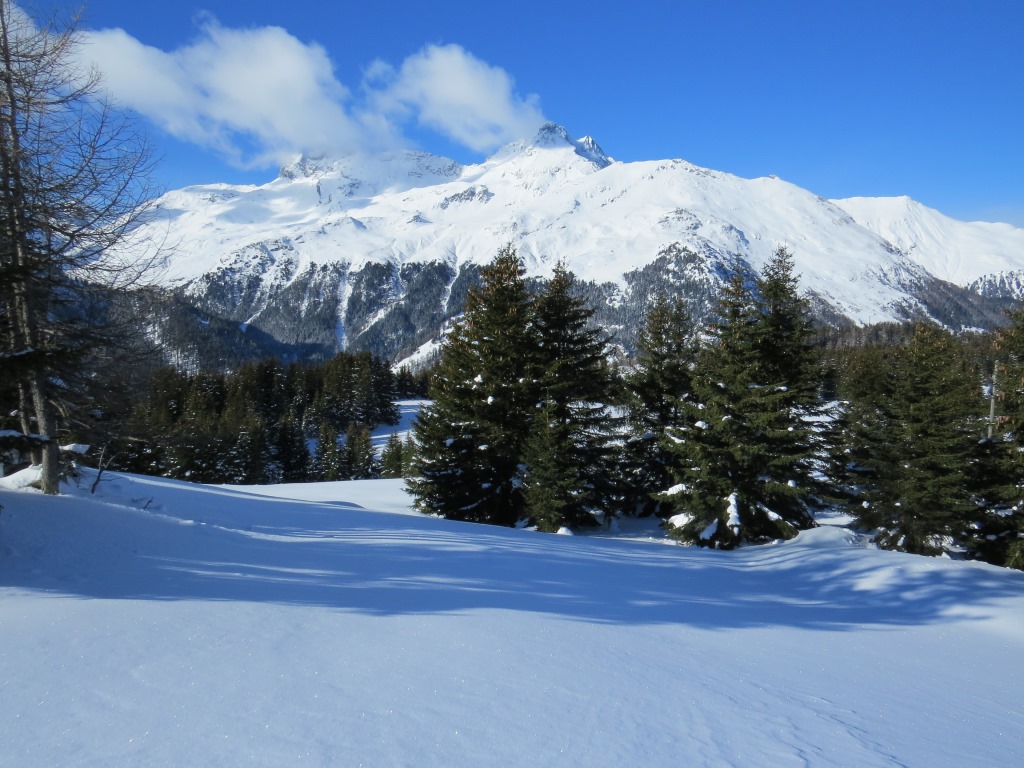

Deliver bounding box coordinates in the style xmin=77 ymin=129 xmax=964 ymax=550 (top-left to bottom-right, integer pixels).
xmin=0 ymin=0 xmax=153 ymax=494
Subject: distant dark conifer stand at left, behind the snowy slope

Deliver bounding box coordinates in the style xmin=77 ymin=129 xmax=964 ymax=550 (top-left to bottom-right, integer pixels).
xmin=82 ymin=352 xmax=424 ymax=484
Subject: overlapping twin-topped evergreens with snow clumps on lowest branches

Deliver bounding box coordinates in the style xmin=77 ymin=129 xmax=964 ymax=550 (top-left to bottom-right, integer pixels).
xmin=663 ymin=256 xmax=818 ymax=549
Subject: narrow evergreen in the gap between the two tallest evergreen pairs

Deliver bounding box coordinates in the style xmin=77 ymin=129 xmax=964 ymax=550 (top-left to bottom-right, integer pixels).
xmin=624 ymin=294 xmax=697 ymax=515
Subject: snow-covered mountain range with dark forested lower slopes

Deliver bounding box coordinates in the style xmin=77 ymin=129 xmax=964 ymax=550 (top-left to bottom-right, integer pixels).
xmin=136 ymin=124 xmax=1024 ymax=368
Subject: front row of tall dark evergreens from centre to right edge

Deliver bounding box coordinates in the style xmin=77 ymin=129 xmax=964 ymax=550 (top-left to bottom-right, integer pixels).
xmin=408 ymin=247 xmax=1024 ymax=567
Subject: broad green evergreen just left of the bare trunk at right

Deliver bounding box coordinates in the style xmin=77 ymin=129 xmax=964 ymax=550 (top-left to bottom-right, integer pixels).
xmin=849 ymin=324 xmax=983 ymax=555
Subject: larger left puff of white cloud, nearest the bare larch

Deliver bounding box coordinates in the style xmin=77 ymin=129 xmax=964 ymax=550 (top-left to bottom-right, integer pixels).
xmin=87 ymin=20 xmax=385 ymax=166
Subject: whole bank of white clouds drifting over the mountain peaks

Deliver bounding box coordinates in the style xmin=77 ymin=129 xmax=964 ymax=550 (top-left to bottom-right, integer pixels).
xmin=83 ymin=16 xmax=544 ymax=168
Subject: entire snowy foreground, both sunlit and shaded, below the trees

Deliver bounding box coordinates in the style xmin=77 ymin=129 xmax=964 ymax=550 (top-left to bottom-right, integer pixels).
xmin=0 ymin=475 xmax=1024 ymax=768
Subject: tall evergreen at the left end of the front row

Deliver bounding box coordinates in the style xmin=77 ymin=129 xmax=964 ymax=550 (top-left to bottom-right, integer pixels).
xmin=408 ymin=246 xmax=537 ymax=525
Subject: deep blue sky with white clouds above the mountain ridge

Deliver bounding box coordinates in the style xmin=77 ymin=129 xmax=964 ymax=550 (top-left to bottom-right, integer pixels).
xmin=70 ymin=0 xmax=1024 ymax=226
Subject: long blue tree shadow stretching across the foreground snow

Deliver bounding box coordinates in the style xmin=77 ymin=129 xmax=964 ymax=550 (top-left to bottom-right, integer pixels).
xmin=0 ymin=476 xmax=1024 ymax=631
